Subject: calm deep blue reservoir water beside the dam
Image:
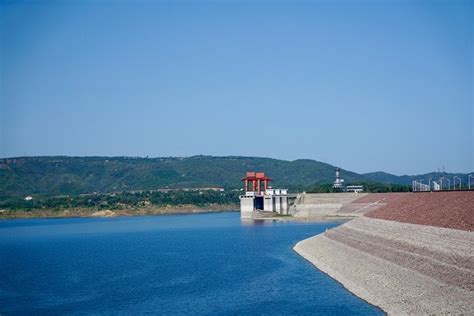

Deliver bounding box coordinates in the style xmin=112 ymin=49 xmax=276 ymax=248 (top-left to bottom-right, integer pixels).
xmin=0 ymin=213 xmax=381 ymax=315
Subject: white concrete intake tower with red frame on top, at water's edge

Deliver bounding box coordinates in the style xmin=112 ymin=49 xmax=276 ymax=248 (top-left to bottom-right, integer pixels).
xmin=240 ymin=172 xmax=288 ymax=219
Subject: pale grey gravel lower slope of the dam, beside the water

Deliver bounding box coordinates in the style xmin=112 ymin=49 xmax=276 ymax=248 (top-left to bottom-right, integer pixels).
xmin=294 ymin=218 xmax=474 ymax=315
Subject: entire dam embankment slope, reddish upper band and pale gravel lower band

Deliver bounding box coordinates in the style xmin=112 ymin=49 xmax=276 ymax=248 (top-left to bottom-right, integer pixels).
xmin=294 ymin=192 xmax=474 ymax=315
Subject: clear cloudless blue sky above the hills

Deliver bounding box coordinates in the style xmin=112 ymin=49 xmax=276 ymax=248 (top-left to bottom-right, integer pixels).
xmin=0 ymin=0 xmax=474 ymax=175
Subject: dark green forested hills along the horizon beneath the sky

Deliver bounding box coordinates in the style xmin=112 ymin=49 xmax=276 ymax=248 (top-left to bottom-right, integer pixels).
xmin=0 ymin=156 xmax=467 ymax=197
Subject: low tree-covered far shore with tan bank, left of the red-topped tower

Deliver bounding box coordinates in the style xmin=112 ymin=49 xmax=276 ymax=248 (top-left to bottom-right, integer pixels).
xmin=0 ymin=190 xmax=240 ymax=218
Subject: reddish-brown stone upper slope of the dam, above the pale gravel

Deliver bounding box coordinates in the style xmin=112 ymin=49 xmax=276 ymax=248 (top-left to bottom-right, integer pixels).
xmin=366 ymin=191 xmax=474 ymax=231
